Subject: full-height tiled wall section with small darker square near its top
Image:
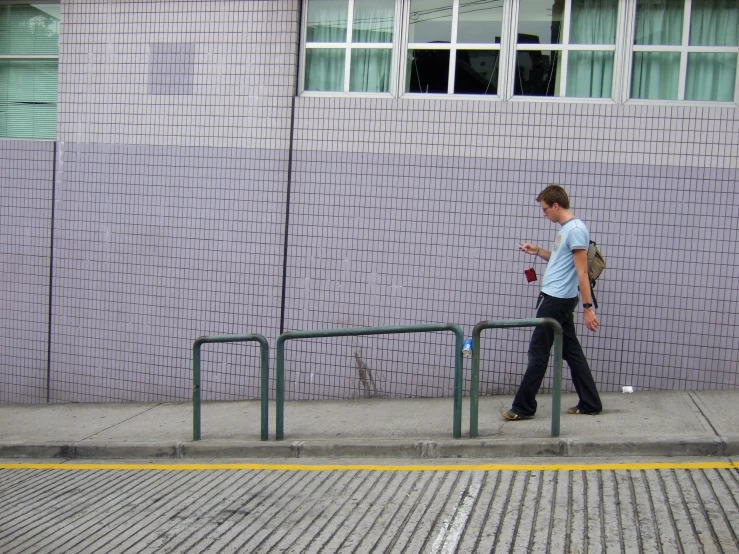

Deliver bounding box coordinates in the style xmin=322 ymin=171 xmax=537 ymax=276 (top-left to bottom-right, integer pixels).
xmin=45 ymin=0 xmax=297 ymax=401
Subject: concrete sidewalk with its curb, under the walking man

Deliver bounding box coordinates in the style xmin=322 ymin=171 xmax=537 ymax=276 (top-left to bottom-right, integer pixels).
xmin=0 ymin=390 xmax=739 ymax=459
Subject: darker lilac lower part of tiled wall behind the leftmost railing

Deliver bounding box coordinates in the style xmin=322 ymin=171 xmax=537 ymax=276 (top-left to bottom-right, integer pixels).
xmin=51 ymin=143 xmax=285 ymax=401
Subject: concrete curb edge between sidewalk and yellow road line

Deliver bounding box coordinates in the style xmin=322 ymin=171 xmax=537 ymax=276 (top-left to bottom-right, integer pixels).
xmin=0 ymin=435 xmax=739 ymax=459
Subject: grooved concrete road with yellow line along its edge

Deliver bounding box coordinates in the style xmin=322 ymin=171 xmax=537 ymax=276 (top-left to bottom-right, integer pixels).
xmin=0 ymin=458 xmax=739 ymax=554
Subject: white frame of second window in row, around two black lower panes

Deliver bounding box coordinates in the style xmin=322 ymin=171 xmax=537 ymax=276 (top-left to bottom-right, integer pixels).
xmin=397 ymin=0 xmax=511 ymax=97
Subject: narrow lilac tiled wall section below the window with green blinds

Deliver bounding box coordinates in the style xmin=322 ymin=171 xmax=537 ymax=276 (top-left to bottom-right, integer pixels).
xmin=0 ymin=140 xmax=54 ymax=402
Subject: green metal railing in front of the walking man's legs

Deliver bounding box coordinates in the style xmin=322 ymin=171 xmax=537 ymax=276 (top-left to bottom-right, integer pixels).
xmin=470 ymin=317 xmax=562 ymax=438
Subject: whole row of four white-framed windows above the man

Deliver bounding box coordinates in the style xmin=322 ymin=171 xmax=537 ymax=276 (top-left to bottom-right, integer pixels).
xmin=301 ymin=0 xmax=739 ymax=103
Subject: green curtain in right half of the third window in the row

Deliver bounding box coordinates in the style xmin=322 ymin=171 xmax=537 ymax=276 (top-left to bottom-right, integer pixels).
xmin=567 ymin=0 xmax=618 ymax=98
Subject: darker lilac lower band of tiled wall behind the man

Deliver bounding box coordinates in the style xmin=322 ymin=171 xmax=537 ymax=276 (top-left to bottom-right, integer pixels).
xmin=286 ymin=138 xmax=739 ymax=396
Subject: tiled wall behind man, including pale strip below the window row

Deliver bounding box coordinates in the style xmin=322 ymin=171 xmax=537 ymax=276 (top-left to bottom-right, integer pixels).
xmin=287 ymin=98 xmax=739 ymax=395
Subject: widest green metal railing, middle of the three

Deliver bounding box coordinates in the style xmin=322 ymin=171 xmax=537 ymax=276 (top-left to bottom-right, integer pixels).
xmin=275 ymin=323 xmax=464 ymax=440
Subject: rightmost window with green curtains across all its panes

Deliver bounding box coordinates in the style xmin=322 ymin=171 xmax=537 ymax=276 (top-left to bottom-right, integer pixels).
xmin=631 ymin=0 xmax=739 ymax=102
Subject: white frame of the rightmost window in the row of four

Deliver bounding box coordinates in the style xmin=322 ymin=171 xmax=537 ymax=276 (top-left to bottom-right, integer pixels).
xmin=621 ymin=0 xmax=739 ymax=106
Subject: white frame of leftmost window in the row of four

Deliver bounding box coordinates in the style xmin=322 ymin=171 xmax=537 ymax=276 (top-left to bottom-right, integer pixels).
xmin=298 ymin=0 xmax=404 ymax=98
